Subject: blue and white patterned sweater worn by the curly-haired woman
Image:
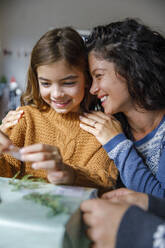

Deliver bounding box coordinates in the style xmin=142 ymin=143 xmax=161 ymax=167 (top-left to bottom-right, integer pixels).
xmin=103 ymin=117 xmax=165 ymax=198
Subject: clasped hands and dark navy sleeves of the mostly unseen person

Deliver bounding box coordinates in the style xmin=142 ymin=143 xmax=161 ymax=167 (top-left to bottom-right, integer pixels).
xmin=81 ymin=188 xmax=165 ymax=248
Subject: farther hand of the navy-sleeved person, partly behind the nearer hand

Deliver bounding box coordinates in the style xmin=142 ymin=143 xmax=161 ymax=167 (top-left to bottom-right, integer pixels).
xmin=102 ymin=188 xmax=148 ymax=210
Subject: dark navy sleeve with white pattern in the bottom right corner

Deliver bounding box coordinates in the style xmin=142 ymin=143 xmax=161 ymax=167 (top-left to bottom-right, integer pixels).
xmin=116 ymin=206 xmax=165 ymax=248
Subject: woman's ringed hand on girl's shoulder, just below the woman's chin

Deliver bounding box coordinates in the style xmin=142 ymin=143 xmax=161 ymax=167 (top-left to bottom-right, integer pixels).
xmin=80 ymin=111 xmax=122 ymax=145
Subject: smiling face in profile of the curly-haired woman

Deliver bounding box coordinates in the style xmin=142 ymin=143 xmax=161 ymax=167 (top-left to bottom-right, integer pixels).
xmin=89 ymin=52 xmax=132 ymax=114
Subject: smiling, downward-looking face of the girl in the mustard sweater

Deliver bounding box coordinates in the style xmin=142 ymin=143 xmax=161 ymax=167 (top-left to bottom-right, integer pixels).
xmin=37 ymin=60 xmax=85 ymax=114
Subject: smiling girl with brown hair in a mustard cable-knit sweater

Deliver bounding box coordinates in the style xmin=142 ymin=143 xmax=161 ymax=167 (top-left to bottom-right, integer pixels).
xmin=0 ymin=27 xmax=118 ymax=187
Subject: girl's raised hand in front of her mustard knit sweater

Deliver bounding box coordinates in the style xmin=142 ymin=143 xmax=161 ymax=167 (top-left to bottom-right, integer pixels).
xmin=20 ymin=144 xmax=75 ymax=185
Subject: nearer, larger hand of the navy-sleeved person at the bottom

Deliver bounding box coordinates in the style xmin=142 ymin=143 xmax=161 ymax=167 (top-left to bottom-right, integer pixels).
xmin=80 ymin=199 xmax=130 ymax=248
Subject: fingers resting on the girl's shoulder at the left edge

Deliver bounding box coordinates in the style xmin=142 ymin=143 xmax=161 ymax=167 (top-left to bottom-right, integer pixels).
xmin=0 ymin=109 xmax=24 ymax=132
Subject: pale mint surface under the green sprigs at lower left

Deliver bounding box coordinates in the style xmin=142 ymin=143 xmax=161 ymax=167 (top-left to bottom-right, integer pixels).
xmin=0 ymin=178 xmax=96 ymax=248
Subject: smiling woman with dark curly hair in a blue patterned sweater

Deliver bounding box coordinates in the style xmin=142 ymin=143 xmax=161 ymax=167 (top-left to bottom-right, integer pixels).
xmin=80 ymin=19 xmax=165 ymax=197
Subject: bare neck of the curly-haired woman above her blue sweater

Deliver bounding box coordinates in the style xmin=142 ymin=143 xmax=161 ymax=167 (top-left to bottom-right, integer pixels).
xmin=125 ymin=110 xmax=165 ymax=140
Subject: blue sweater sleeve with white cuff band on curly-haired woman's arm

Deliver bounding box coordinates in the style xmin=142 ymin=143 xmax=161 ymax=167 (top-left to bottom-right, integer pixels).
xmin=104 ymin=134 xmax=165 ymax=198
